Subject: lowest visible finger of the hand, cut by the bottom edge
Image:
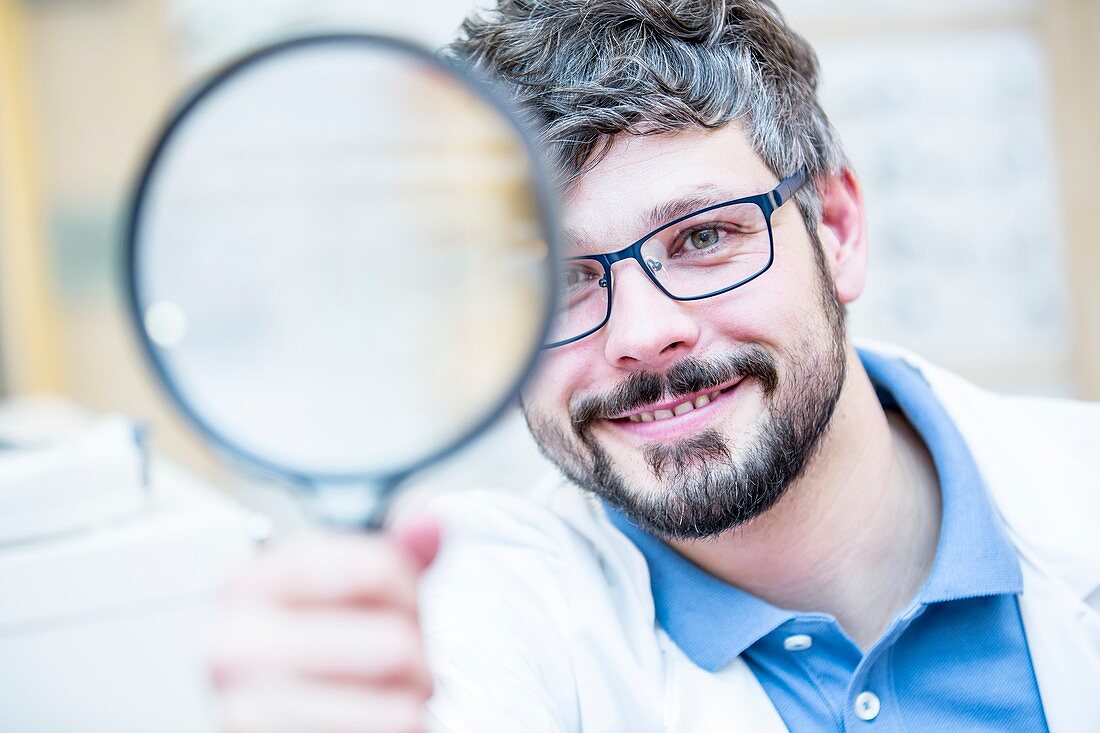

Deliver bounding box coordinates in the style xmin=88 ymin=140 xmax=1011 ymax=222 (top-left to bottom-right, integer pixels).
xmin=218 ymin=682 xmax=427 ymax=733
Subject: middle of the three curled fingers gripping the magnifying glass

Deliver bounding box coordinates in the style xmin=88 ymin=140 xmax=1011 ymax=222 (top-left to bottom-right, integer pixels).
xmin=210 ymin=608 xmax=432 ymax=699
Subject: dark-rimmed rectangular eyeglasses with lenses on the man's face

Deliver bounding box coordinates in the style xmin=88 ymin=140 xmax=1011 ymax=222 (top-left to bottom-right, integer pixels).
xmin=542 ymin=169 xmax=809 ymax=349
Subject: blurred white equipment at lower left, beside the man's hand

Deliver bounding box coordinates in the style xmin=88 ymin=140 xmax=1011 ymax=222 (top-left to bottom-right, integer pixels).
xmin=0 ymin=401 xmax=263 ymax=733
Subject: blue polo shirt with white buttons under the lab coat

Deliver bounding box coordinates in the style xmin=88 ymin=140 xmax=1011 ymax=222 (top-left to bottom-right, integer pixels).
xmin=607 ymin=352 xmax=1047 ymax=733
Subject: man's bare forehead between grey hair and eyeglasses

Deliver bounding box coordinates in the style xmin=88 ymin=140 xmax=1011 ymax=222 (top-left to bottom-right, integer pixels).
xmin=562 ymin=123 xmax=778 ymax=243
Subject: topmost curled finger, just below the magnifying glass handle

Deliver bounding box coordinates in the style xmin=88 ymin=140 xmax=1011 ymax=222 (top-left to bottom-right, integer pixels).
xmin=226 ymin=533 xmax=419 ymax=609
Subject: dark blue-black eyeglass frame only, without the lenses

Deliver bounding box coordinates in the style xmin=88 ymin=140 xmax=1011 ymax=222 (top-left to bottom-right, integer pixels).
xmin=542 ymin=168 xmax=810 ymax=350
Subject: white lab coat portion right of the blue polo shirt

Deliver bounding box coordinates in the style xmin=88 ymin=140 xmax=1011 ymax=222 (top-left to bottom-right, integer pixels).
xmin=905 ymin=343 xmax=1100 ymax=733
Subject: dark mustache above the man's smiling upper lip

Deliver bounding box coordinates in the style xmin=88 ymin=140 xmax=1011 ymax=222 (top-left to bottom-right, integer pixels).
xmin=569 ymin=346 xmax=779 ymax=424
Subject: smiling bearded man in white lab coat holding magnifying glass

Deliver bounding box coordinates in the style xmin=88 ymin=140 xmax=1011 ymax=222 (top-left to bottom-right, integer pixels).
xmin=216 ymin=0 xmax=1100 ymax=733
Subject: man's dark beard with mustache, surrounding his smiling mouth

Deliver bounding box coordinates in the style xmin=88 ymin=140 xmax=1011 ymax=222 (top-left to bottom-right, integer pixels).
xmin=525 ymin=245 xmax=846 ymax=539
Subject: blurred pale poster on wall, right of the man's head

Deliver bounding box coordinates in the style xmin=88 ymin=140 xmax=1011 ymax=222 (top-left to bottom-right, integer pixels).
xmin=818 ymin=29 xmax=1071 ymax=394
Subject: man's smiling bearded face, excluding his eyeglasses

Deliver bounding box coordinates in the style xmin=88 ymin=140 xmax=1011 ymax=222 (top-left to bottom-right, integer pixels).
xmin=523 ymin=124 xmax=846 ymax=538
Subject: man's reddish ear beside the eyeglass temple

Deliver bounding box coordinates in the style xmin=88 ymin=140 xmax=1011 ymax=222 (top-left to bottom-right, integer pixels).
xmin=817 ymin=168 xmax=867 ymax=305
